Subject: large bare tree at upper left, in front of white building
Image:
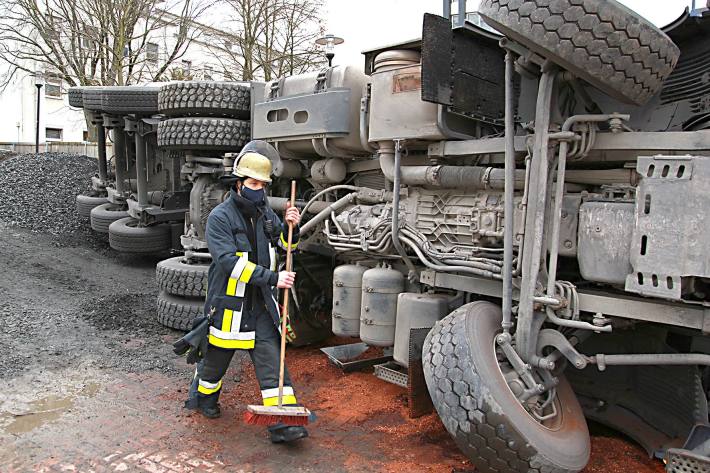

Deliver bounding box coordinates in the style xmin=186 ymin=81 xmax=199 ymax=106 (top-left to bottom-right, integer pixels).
xmin=0 ymin=0 xmax=209 ymax=87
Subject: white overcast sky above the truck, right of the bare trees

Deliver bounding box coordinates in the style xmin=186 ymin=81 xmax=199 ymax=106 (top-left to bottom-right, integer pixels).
xmin=325 ymin=0 xmax=705 ymax=67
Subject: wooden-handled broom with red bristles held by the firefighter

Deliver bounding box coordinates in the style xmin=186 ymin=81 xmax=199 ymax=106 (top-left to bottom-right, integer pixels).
xmin=244 ymin=181 xmax=311 ymax=425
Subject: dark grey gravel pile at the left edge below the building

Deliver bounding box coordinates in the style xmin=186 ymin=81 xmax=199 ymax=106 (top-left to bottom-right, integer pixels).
xmin=0 ymin=153 xmax=98 ymax=236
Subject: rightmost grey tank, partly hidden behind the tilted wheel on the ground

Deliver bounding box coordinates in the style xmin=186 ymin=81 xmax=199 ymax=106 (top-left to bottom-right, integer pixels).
xmin=394 ymin=292 xmax=454 ymax=367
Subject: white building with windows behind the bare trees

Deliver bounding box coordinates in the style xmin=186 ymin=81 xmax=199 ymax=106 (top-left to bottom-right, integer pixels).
xmin=0 ymin=11 xmax=236 ymax=154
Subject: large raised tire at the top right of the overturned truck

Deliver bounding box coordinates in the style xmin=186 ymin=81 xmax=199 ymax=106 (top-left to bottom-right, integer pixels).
xmin=479 ymin=0 xmax=680 ymax=105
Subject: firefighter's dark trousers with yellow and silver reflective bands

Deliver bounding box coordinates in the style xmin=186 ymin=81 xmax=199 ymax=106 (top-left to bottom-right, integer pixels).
xmin=186 ymin=309 xmax=297 ymax=407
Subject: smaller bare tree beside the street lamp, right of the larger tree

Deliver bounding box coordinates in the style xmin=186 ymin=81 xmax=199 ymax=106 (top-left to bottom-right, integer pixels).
xmin=211 ymin=0 xmax=324 ymax=80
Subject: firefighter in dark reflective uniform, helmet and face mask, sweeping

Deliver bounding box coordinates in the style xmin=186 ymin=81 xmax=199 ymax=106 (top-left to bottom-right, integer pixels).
xmin=185 ymin=141 xmax=308 ymax=443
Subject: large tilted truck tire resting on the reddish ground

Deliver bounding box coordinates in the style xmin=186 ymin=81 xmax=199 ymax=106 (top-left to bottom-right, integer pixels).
xmin=422 ymin=301 xmax=590 ymax=473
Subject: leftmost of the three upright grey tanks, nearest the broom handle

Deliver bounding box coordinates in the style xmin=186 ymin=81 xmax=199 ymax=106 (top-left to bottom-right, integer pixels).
xmin=332 ymin=264 xmax=367 ymax=337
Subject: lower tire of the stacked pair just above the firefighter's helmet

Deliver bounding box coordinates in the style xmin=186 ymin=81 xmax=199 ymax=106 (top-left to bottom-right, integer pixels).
xmin=158 ymin=118 xmax=249 ymax=152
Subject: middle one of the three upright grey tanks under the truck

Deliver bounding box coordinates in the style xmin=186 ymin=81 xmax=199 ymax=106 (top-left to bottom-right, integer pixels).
xmin=360 ymin=266 xmax=404 ymax=347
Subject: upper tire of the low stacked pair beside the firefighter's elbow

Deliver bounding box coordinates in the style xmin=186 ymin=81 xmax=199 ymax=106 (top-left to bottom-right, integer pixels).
xmin=155 ymin=256 xmax=210 ymax=297
